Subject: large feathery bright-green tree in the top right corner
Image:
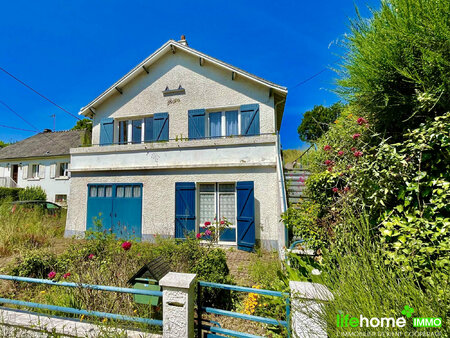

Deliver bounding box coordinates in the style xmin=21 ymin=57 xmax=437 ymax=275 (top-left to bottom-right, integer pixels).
xmin=338 ymin=0 xmax=450 ymax=141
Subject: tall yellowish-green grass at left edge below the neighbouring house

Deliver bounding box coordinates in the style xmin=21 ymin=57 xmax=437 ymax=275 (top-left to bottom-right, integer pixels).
xmin=0 ymin=201 xmax=66 ymax=257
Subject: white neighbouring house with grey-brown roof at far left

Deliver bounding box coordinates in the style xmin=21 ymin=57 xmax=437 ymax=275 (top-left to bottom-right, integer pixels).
xmin=0 ymin=129 xmax=84 ymax=205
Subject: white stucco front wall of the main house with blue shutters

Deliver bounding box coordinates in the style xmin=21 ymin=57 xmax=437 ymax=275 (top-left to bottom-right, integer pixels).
xmin=66 ymin=40 xmax=284 ymax=249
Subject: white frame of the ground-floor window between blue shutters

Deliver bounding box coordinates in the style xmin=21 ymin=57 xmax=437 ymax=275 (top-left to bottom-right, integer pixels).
xmin=196 ymin=181 xmax=237 ymax=245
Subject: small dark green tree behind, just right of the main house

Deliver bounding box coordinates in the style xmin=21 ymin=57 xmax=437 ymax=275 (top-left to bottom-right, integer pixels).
xmin=297 ymin=102 xmax=345 ymax=142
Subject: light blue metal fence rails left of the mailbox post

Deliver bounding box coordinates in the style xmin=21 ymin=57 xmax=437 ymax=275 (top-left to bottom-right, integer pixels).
xmin=0 ymin=275 xmax=163 ymax=326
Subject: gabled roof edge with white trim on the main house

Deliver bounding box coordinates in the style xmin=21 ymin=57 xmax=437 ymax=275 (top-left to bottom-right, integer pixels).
xmin=79 ymin=40 xmax=287 ymax=119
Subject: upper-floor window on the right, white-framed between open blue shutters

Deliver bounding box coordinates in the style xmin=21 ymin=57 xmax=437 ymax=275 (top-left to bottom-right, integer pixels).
xmin=205 ymin=108 xmax=241 ymax=138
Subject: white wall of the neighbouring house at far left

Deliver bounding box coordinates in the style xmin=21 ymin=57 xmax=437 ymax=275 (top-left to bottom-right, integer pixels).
xmin=0 ymin=155 xmax=70 ymax=205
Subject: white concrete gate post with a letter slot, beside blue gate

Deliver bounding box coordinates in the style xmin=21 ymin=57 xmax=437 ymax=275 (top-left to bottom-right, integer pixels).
xmin=159 ymin=272 xmax=197 ymax=338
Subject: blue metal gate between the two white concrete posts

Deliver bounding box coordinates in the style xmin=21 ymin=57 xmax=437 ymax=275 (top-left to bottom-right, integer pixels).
xmin=197 ymin=281 xmax=290 ymax=338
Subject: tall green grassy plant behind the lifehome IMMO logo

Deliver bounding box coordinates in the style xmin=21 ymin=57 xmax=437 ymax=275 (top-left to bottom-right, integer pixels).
xmin=323 ymin=213 xmax=450 ymax=337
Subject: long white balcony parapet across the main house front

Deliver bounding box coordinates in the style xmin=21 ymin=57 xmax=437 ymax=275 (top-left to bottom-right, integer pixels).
xmin=70 ymin=134 xmax=277 ymax=172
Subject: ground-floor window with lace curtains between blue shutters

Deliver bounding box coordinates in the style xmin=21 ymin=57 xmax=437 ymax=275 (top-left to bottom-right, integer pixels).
xmin=197 ymin=182 xmax=237 ymax=244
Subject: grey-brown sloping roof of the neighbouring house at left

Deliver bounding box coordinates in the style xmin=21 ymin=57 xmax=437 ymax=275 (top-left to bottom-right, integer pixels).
xmin=0 ymin=130 xmax=85 ymax=160
